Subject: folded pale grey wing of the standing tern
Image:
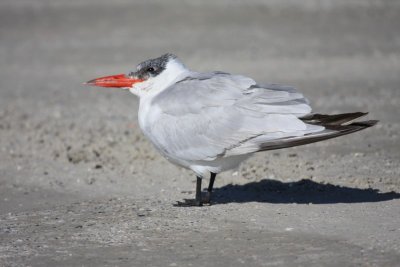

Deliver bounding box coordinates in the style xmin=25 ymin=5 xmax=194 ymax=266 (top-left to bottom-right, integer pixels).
xmin=151 ymin=72 xmax=324 ymax=160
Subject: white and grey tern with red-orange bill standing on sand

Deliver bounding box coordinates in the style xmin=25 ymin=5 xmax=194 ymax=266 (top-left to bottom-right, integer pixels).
xmin=86 ymin=54 xmax=377 ymax=206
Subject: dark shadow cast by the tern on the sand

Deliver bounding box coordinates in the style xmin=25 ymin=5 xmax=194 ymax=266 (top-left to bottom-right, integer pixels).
xmin=212 ymin=179 xmax=400 ymax=205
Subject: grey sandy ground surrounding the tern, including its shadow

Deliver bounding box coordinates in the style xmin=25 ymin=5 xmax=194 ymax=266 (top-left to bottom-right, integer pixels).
xmin=0 ymin=0 xmax=400 ymax=266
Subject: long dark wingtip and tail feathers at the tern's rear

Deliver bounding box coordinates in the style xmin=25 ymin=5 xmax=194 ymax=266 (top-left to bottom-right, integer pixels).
xmin=259 ymin=112 xmax=378 ymax=151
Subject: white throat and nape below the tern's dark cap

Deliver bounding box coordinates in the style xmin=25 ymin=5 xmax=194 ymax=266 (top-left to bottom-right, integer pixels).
xmin=129 ymin=58 xmax=190 ymax=98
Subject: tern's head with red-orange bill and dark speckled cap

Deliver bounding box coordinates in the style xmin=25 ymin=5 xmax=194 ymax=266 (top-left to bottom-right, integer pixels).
xmin=85 ymin=54 xmax=188 ymax=96
